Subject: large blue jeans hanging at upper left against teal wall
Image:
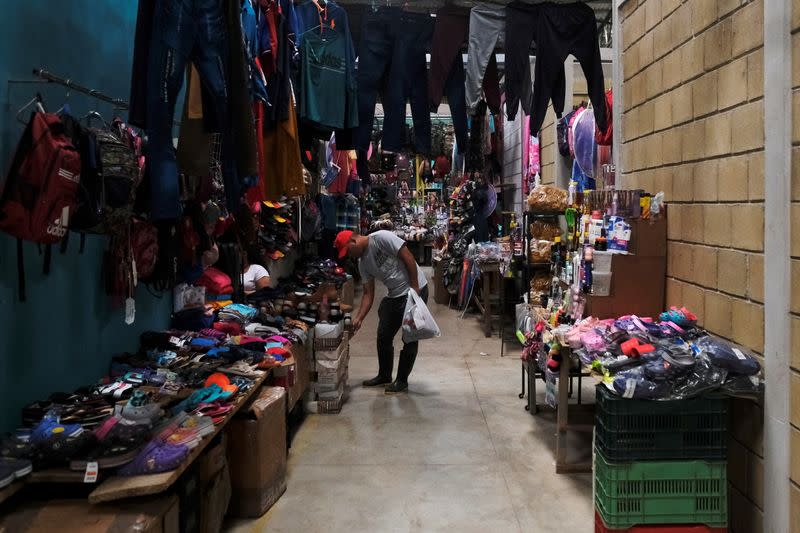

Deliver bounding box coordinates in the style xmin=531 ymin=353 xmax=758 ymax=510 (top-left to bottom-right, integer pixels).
xmin=147 ymin=0 xmax=236 ymax=220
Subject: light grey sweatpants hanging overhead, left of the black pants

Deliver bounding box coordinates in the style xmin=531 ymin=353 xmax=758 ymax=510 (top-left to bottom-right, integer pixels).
xmin=465 ymin=5 xmax=506 ymax=112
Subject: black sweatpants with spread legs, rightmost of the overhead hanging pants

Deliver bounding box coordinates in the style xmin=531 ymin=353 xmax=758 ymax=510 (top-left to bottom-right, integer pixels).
xmin=531 ymin=2 xmax=608 ymax=135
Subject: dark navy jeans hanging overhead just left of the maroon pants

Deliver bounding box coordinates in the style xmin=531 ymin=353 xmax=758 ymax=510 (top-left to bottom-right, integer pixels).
xmin=383 ymin=12 xmax=433 ymax=155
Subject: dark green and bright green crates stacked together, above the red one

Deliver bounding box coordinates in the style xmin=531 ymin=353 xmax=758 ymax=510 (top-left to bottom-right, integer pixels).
xmin=594 ymin=385 xmax=728 ymax=533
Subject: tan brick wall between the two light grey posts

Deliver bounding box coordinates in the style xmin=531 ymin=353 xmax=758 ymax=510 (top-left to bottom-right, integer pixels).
xmin=621 ymin=0 xmax=768 ymax=533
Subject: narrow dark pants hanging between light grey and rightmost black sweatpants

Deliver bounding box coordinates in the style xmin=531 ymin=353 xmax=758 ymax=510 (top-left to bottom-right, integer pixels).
xmin=505 ymin=1 xmax=566 ymax=120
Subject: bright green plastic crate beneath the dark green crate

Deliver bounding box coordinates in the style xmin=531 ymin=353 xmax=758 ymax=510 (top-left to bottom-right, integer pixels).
xmin=594 ymin=450 xmax=728 ymax=529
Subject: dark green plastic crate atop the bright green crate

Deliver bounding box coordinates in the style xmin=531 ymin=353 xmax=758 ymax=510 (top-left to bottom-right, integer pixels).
xmin=595 ymin=385 xmax=728 ymax=461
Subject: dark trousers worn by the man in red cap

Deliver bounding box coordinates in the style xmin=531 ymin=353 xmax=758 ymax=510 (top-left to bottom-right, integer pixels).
xmin=378 ymin=285 xmax=428 ymax=382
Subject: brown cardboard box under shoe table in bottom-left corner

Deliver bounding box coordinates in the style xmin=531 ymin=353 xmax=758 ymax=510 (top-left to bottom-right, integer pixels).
xmin=0 ymin=494 xmax=180 ymax=533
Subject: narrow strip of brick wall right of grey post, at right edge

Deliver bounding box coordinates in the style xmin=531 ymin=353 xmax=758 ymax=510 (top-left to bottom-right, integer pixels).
xmin=790 ymin=0 xmax=800 ymax=533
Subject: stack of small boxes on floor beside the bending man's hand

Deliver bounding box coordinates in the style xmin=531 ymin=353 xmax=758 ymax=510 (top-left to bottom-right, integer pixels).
xmin=314 ymin=322 xmax=350 ymax=414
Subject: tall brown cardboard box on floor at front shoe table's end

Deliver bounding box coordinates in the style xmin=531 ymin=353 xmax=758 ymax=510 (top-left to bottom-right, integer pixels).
xmin=228 ymin=387 xmax=286 ymax=518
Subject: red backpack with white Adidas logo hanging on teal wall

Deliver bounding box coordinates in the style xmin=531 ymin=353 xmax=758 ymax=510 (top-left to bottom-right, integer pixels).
xmin=0 ymin=113 xmax=81 ymax=301
